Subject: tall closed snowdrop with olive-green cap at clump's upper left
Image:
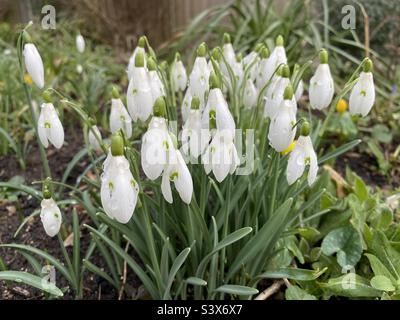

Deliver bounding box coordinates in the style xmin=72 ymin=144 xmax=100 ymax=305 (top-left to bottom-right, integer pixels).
xmin=126 ymin=52 xmax=154 ymax=122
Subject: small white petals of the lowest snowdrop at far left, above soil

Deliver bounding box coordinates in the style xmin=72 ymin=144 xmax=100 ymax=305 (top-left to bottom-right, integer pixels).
xmin=40 ymin=197 xmax=62 ymax=237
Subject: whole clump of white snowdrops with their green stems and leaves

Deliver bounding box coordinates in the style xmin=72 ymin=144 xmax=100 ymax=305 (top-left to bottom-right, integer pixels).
xmin=0 ymin=23 xmax=375 ymax=299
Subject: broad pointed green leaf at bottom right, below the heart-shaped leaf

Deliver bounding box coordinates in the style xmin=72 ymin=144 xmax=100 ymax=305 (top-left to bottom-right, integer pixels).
xmin=320 ymin=273 xmax=382 ymax=298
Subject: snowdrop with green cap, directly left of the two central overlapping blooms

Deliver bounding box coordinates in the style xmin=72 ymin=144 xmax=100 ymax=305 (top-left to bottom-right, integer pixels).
xmin=181 ymin=97 xmax=210 ymax=159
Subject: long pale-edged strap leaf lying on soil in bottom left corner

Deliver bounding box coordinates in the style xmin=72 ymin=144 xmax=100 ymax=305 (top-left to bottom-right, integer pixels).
xmin=0 ymin=271 xmax=64 ymax=297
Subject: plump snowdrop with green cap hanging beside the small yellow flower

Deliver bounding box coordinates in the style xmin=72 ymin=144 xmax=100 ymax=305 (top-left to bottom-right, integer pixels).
xmin=268 ymin=85 xmax=296 ymax=152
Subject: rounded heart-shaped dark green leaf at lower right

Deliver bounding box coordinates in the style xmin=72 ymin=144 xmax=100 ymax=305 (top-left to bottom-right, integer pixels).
xmin=321 ymin=226 xmax=362 ymax=267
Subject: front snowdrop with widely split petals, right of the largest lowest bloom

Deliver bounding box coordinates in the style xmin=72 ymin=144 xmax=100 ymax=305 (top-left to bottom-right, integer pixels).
xmin=161 ymin=145 xmax=193 ymax=204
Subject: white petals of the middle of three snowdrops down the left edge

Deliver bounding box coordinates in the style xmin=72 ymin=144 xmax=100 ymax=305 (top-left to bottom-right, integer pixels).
xmin=38 ymin=99 xmax=64 ymax=149
